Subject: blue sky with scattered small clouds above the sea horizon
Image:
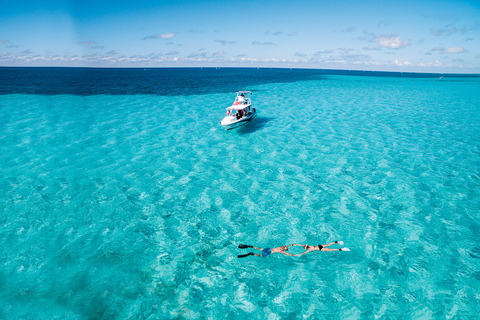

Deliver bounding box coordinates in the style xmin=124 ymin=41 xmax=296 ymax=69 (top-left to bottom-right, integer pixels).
xmin=0 ymin=0 xmax=480 ymax=73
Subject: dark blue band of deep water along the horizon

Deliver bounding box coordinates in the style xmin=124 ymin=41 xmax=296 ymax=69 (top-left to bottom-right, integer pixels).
xmin=0 ymin=68 xmax=479 ymax=96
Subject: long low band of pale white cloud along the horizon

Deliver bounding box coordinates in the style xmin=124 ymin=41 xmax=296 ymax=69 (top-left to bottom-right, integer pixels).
xmin=0 ymin=48 xmax=474 ymax=71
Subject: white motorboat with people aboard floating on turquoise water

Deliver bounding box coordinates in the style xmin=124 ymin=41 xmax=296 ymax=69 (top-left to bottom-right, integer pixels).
xmin=220 ymin=91 xmax=257 ymax=130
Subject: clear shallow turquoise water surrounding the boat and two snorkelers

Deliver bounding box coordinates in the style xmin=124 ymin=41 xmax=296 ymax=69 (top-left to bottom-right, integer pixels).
xmin=0 ymin=71 xmax=480 ymax=319
